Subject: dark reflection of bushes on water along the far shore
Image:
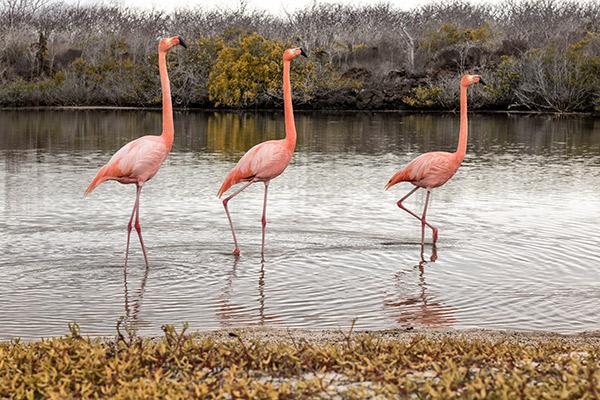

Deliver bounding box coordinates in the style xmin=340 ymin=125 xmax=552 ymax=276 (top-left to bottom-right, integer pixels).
xmin=0 ymin=110 xmax=600 ymax=160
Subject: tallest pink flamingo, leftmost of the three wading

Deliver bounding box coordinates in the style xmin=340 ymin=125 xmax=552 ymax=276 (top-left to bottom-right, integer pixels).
xmin=85 ymin=36 xmax=187 ymax=267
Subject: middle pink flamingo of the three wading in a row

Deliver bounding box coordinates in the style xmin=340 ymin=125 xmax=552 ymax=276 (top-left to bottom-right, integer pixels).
xmin=217 ymin=48 xmax=307 ymax=256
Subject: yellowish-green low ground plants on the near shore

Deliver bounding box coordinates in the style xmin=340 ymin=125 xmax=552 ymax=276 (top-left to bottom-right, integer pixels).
xmin=0 ymin=326 xmax=600 ymax=399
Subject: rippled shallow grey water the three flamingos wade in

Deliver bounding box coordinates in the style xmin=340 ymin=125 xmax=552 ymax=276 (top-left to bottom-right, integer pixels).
xmin=0 ymin=111 xmax=600 ymax=338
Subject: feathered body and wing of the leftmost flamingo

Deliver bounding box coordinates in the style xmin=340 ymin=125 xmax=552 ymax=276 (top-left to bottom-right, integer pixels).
xmin=85 ymin=135 xmax=168 ymax=194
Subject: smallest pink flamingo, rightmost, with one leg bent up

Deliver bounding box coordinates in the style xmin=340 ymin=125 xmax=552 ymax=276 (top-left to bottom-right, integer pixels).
xmin=385 ymin=75 xmax=485 ymax=246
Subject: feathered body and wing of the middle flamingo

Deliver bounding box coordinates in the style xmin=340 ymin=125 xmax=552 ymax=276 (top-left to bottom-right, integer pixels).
xmin=217 ymin=140 xmax=292 ymax=197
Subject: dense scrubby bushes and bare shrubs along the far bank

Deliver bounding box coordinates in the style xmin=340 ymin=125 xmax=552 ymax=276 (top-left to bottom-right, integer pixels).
xmin=0 ymin=0 xmax=600 ymax=112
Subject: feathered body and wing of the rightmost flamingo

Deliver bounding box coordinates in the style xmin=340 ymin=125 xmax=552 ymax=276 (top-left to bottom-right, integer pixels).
xmin=385 ymin=151 xmax=458 ymax=190
